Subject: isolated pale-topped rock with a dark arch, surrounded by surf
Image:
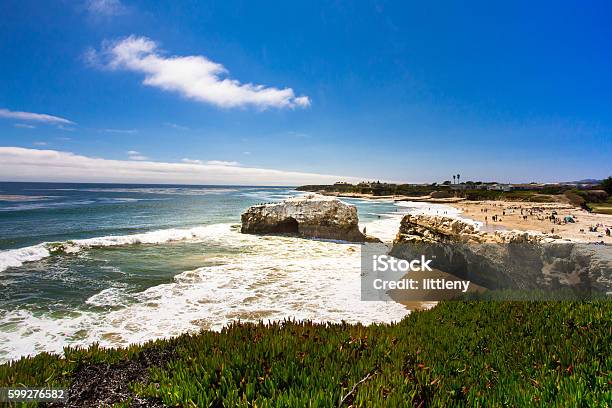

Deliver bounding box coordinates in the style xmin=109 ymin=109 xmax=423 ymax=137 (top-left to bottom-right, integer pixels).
xmin=241 ymin=194 xmax=366 ymax=242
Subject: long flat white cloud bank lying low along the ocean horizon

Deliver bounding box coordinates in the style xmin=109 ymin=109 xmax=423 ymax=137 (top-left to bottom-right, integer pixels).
xmin=0 ymin=147 xmax=360 ymax=185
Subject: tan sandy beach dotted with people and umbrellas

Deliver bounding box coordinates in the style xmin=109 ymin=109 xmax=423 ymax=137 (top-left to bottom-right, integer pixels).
xmin=449 ymin=201 xmax=612 ymax=244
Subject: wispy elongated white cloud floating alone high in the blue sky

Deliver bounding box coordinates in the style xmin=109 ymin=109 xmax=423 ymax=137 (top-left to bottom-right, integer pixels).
xmin=85 ymin=35 xmax=310 ymax=109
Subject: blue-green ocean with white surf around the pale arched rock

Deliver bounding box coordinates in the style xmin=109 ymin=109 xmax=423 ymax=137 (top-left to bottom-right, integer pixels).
xmin=0 ymin=183 xmax=406 ymax=360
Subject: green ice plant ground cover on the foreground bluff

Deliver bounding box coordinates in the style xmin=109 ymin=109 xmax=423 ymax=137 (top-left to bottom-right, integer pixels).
xmin=0 ymin=301 xmax=612 ymax=407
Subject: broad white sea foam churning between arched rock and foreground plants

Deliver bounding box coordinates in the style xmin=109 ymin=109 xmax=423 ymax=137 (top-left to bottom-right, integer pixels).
xmin=0 ymin=216 xmax=408 ymax=361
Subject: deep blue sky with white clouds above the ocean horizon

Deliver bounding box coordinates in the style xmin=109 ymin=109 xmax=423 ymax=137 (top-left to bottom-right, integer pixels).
xmin=0 ymin=0 xmax=612 ymax=184
